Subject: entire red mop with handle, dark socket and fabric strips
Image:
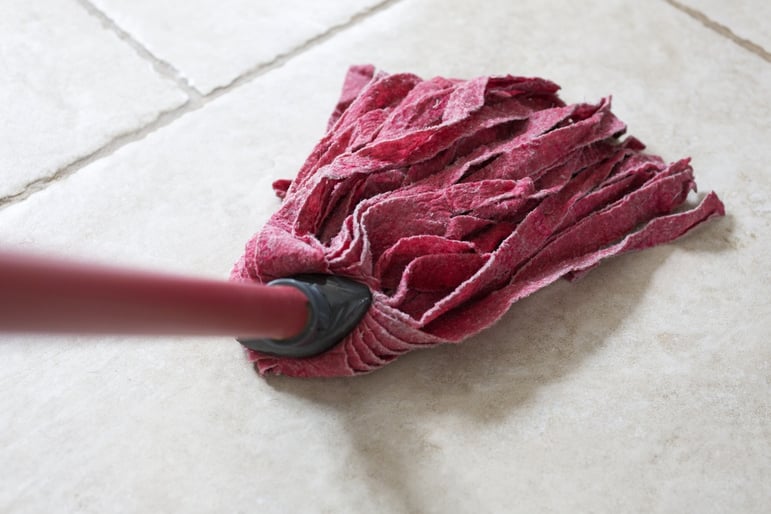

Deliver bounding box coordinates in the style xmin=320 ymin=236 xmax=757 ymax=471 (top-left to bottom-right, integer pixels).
xmin=0 ymin=65 xmax=724 ymax=377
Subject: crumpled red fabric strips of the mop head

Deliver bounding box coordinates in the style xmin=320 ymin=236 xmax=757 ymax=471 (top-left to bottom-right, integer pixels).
xmin=232 ymin=66 xmax=724 ymax=376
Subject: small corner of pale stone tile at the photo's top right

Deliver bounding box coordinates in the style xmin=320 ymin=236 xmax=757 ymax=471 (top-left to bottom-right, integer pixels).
xmin=681 ymin=0 xmax=771 ymax=52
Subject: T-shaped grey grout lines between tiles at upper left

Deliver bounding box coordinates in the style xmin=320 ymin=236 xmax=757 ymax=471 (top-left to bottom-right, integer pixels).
xmin=0 ymin=0 xmax=402 ymax=210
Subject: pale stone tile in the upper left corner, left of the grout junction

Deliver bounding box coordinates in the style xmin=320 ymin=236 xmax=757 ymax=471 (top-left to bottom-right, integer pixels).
xmin=0 ymin=0 xmax=186 ymax=197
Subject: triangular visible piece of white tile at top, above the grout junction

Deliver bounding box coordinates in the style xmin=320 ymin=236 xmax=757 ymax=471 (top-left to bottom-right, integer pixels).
xmin=93 ymin=0 xmax=390 ymax=94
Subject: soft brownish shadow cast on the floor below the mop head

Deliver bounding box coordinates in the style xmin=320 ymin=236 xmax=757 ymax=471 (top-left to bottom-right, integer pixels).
xmin=268 ymin=214 xmax=734 ymax=512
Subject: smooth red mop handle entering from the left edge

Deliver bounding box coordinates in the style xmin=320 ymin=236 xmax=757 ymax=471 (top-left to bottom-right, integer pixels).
xmin=0 ymin=251 xmax=309 ymax=339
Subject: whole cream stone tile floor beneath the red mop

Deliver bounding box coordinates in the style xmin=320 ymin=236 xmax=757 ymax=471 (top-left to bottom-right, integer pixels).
xmin=0 ymin=0 xmax=771 ymax=513
